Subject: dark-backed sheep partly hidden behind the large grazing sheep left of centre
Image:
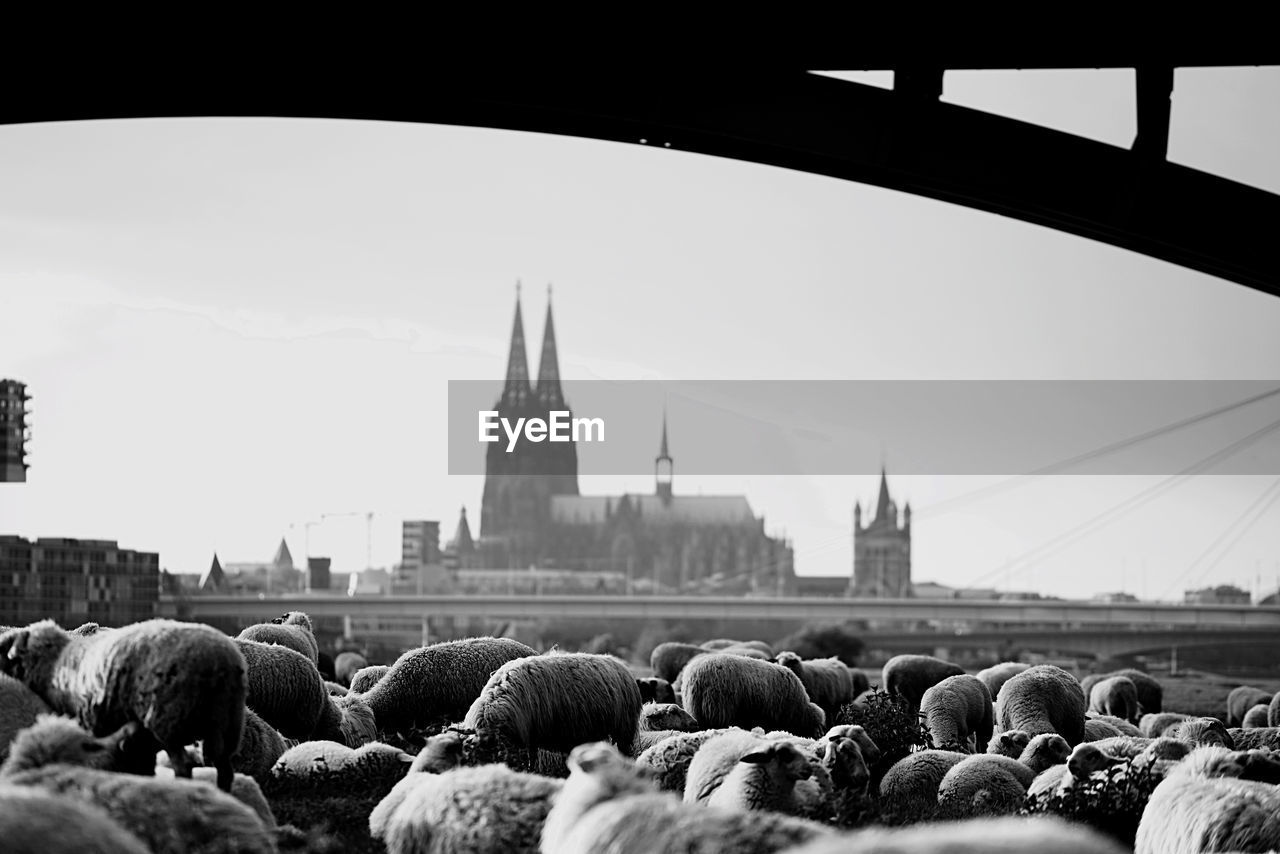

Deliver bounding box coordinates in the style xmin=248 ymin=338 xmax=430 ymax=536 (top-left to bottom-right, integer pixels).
xmin=357 ymin=638 xmax=537 ymax=732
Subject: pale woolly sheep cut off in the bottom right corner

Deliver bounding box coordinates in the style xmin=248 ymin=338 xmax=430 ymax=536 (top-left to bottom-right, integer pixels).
xmin=1134 ymin=746 xmax=1280 ymax=854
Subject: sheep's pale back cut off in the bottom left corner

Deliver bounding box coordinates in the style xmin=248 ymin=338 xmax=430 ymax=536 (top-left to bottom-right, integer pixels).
xmin=0 ymin=785 xmax=151 ymax=854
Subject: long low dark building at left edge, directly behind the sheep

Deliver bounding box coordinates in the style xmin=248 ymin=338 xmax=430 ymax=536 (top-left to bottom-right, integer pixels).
xmin=0 ymin=536 xmax=160 ymax=629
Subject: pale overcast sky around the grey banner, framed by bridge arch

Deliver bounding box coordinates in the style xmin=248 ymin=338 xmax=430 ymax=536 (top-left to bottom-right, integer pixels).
xmin=0 ymin=68 xmax=1280 ymax=597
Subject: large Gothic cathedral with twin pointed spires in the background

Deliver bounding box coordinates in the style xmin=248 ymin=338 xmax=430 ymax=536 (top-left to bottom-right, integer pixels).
xmin=447 ymin=291 xmax=795 ymax=595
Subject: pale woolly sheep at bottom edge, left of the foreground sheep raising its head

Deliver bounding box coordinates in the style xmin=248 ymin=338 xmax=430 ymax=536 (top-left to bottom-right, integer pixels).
xmin=370 ymin=764 xmax=563 ymax=854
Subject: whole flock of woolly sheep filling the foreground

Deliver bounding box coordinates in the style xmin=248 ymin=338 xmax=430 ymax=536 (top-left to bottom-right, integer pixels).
xmin=0 ymin=612 xmax=1280 ymax=854
